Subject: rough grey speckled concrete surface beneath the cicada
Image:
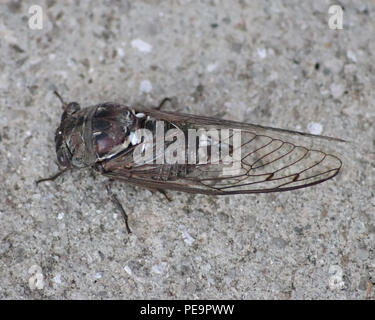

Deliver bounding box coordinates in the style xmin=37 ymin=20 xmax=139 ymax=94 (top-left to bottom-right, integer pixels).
xmin=0 ymin=0 xmax=375 ymax=299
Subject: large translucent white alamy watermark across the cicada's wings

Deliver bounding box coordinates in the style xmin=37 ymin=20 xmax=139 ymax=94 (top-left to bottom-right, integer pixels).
xmin=129 ymin=121 xmax=241 ymax=175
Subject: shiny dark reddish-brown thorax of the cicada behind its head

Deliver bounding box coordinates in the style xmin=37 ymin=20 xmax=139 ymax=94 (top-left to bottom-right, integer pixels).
xmin=65 ymin=103 xmax=158 ymax=167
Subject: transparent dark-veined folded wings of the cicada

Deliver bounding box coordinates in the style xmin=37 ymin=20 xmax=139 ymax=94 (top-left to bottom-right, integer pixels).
xmin=102 ymin=109 xmax=343 ymax=195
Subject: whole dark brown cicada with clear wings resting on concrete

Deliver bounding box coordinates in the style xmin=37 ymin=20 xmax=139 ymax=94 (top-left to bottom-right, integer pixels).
xmin=37 ymin=91 xmax=344 ymax=233
